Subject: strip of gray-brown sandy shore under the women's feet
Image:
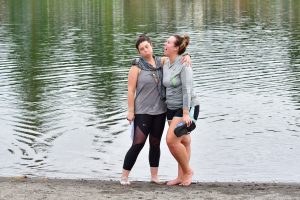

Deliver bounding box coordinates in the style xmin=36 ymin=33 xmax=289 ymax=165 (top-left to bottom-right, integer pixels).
xmin=0 ymin=177 xmax=300 ymax=200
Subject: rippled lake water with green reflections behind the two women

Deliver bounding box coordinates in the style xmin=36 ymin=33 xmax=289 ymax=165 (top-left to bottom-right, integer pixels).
xmin=0 ymin=0 xmax=300 ymax=182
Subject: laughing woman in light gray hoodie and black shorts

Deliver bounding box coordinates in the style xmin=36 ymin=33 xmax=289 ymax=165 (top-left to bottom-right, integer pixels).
xmin=163 ymin=35 xmax=199 ymax=186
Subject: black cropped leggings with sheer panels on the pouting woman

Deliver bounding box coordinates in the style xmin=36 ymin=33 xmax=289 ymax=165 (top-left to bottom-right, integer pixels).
xmin=123 ymin=113 xmax=166 ymax=171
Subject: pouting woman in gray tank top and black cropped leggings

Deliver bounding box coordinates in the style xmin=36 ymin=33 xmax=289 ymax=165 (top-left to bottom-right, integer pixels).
xmin=120 ymin=35 xmax=190 ymax=185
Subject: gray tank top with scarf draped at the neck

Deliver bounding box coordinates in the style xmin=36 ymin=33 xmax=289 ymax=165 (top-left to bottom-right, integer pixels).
xmin=133 ymin=57 xmax=167 ymax=115
